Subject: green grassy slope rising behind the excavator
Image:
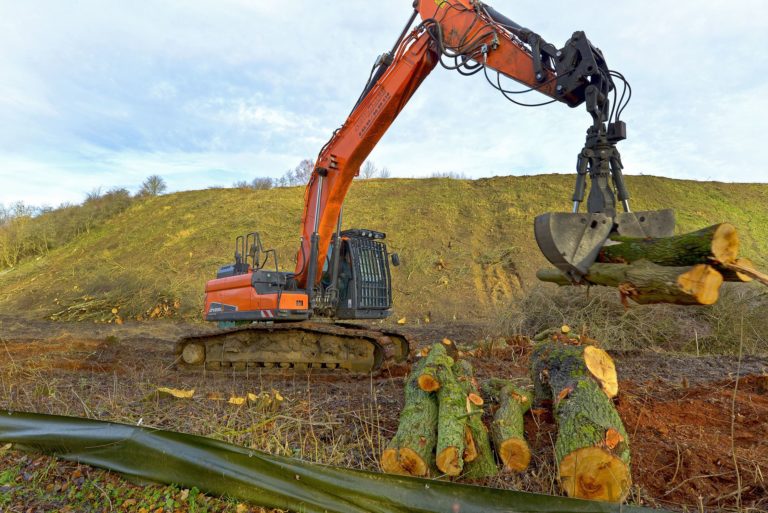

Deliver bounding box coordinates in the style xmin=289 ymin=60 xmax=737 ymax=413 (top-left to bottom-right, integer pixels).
xmin=0 ymin=175 xmax=768 ymax=320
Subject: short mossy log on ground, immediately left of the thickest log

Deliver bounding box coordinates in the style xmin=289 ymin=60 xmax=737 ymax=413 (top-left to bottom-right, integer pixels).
xmin=483 ymin=378 xmax=531 ymax=472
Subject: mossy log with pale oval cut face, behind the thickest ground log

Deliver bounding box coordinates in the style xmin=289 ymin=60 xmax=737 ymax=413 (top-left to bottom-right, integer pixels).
xmin=531 ymin=341 xmax=619 ymax=405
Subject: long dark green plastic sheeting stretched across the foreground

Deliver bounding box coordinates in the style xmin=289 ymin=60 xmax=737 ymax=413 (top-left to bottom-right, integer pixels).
xmin=0 ymin=412 xmax=659 ymax=513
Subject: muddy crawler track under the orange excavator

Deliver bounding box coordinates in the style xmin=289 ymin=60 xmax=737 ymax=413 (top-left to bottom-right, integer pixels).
xmin=176 ymin=321 xmax=411 ymax=373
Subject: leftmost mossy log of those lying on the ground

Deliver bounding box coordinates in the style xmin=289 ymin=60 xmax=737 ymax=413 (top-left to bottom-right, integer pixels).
xmin=381 ymin=359 xmax=438 ymax=477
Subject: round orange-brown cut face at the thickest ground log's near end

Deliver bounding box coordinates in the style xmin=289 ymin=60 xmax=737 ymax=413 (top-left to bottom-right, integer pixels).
xmin=560 ymin=447 xmax=632 ymax=502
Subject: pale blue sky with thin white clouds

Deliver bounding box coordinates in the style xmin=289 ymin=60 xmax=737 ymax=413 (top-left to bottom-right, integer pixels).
xmin=0 ymin=0 xmax=768 ymax=208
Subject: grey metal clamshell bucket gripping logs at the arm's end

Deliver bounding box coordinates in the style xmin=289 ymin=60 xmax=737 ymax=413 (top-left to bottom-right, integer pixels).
xmin=534 ymin=209 xmax=675 ymax=280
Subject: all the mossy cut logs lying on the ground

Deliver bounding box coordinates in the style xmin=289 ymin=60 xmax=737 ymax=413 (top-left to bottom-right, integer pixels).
xmin=381 ymin=326 xmax=632 ymax=502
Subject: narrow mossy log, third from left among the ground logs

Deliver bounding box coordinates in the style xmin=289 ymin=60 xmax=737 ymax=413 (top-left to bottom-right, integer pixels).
xmin=453 ymin=360 xmax=499 ymax=479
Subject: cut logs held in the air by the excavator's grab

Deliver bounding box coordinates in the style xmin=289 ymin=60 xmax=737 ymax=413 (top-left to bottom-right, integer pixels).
xmin=536 ymin=223 xmax=768 ymax=305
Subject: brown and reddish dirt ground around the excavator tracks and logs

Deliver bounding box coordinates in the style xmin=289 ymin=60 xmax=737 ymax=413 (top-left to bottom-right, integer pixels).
xmin=0 ymin=316 xmax=768 ymax=511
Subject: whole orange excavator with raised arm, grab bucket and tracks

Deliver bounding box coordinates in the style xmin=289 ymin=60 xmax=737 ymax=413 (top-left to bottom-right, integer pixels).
xmin=177 ymin=0 xmax=674 ymax=371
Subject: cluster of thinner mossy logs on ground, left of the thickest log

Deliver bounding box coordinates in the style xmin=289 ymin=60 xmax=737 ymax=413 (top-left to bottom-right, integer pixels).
xmin=381 ymin=339 xmax=530 ymax=479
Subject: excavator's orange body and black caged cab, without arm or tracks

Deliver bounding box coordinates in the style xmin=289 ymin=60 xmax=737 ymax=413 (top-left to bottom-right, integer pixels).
xmin=205 ymin=229 xmax=398 ymax=327
